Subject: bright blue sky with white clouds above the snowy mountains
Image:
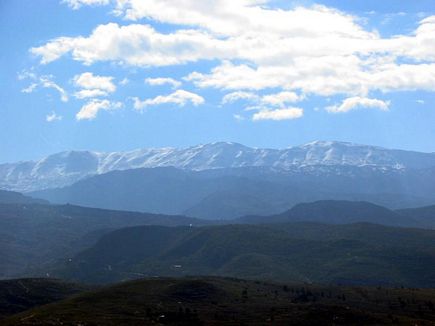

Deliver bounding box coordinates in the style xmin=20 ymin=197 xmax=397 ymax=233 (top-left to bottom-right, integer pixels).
xmin=0 ymin=0 xmax=435 ymax=163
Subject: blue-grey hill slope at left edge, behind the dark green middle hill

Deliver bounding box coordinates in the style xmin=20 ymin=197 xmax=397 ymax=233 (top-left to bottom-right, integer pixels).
xmin=0 ymin=204 xmax=208 ymax=278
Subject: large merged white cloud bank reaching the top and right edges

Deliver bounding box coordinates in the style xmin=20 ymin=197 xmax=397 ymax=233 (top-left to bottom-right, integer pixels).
xmin=31 ymin=0 xmax=435 ymax=114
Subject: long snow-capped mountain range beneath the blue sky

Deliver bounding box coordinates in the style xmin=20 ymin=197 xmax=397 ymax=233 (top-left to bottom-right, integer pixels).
xmin=0 ymin=141 xmax=435 ymax=192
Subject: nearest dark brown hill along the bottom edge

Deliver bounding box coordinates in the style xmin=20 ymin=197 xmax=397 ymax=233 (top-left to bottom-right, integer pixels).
xmin=3 ymin=277 xmax=435 ymax=326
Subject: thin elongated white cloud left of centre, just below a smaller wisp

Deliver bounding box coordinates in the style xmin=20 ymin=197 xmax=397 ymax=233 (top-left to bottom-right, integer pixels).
xmin=133 ymin=89 xmax=205 ymax=110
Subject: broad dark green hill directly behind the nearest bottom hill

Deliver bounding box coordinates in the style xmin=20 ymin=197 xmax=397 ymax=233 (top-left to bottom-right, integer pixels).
xmin=56 ymin=223 xmax=435 ymax=287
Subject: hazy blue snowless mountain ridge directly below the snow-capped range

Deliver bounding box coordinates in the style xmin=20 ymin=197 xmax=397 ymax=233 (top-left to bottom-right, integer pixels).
xmin=31 ymin=167 xmax=435 ymax=219
